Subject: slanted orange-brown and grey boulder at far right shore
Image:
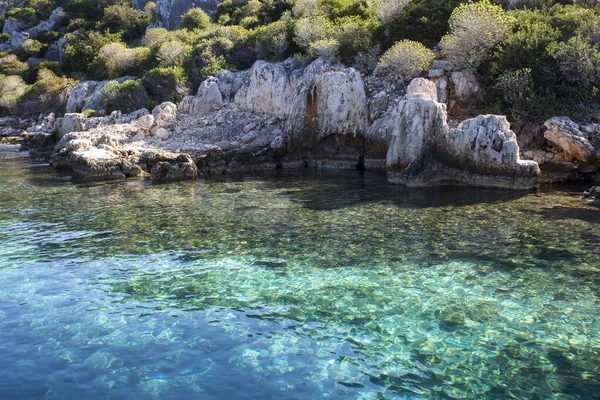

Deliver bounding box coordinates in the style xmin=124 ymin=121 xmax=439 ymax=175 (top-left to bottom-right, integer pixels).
xmin=544 ymin=117 xmax=596 ymax=162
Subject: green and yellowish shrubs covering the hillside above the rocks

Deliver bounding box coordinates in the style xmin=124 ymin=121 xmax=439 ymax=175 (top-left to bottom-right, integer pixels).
xmin=0 ymin=0 xmax=600 ymax=124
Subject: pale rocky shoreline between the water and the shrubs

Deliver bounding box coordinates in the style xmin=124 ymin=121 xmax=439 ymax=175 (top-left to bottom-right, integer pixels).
xmin=0 ymin=59 xmax=600 ymax=189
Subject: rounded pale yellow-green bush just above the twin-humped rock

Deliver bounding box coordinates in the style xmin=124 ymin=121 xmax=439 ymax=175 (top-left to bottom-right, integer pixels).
xmin=377 ymin=40 xmax=435 ymax=81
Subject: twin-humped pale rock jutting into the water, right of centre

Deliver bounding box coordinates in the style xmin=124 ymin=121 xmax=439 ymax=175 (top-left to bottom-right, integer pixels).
xmin=382 ymin=79 xmax=540 ymax=189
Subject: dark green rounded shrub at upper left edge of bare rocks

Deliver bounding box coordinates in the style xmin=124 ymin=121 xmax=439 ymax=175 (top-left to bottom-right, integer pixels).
xmin=142 ymin=67 xmax=188 ymax=104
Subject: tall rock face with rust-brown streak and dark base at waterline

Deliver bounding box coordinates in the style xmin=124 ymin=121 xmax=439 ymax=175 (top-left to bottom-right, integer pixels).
xmin=283 ymin=60 xmax=369 ymax=169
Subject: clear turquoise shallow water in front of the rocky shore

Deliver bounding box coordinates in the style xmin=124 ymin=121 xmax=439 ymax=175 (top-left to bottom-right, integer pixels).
xmin=0 ymin=145 xmax=600 ymax=399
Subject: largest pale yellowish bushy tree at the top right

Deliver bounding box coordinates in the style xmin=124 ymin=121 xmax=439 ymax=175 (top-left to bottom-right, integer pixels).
xmin=442 ymin=0 xmax=513 ymax=69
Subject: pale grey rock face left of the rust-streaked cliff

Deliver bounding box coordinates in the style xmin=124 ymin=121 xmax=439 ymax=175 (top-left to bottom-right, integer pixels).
xmin=235 ymin=61 xmax=294 ymax=116
